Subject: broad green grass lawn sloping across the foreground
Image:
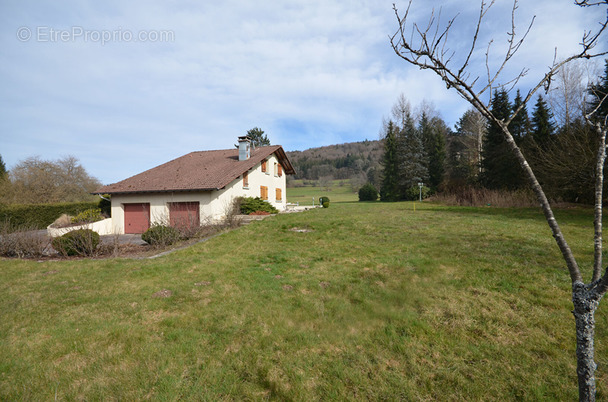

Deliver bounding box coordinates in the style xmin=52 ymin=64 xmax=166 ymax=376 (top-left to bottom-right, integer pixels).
xmin=0 ymin=203 xmax=608 ymax=401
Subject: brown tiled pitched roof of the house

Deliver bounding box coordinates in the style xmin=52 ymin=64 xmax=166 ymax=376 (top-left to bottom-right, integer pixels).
xmin=93 ymin=145 xmax=295 ymax=194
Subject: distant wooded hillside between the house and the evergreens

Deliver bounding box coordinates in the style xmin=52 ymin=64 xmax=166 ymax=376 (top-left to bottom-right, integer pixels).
xmin=287 ymin=140 xmax=382 ymax=182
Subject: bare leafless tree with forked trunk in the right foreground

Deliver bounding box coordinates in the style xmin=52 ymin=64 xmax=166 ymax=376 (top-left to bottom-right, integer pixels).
xmin=390 ymin=0 xmax=608 ymax=401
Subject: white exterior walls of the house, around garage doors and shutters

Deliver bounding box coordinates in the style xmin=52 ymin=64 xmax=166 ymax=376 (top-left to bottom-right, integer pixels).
xmin=112 ymin=154 xmax=287 ymax=233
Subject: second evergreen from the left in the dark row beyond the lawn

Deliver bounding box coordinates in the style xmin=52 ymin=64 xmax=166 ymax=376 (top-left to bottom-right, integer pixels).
xmin=397 ymin=114 xmax=429 ymax=199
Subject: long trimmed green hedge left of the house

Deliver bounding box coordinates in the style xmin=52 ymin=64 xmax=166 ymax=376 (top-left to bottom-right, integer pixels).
xmin=0 ymin=202 xmax=99 ymax=229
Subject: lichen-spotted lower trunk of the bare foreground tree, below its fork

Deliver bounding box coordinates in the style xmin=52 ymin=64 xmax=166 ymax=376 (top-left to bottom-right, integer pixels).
xmin=572 ymin=282 xmax=602 ymax=402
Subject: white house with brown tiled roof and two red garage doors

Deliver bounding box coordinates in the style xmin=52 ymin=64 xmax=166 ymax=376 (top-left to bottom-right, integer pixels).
xmin=94 ymin=137 xmax=295 ymax=234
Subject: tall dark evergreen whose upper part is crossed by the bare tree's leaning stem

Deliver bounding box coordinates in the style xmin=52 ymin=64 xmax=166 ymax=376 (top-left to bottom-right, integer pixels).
xmin=481 ymin=89 xmax=524 ymax=190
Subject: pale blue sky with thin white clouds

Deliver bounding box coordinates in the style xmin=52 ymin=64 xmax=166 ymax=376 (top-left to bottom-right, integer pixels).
xmin=0 ymin=0 xmax=608 ymax=184
